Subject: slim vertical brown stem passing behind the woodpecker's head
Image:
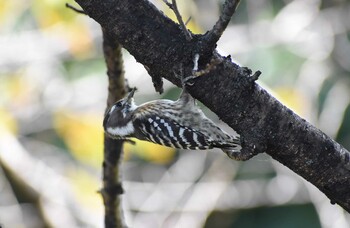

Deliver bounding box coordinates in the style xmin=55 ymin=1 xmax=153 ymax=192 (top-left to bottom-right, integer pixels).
xmin=101 ymin=29 xmax=126 ymax=228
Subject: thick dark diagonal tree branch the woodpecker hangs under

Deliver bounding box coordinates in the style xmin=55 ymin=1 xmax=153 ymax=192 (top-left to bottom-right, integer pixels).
xmin=76 ymin=0 xmax=350 ymax=211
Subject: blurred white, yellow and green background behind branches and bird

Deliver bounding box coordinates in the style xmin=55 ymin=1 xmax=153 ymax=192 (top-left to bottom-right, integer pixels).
xmin=0 ymin=0 xmax=350 ymax=228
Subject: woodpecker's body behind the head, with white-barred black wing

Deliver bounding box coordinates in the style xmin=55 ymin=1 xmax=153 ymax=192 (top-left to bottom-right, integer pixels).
xmin=134 ymin=99 xmax=239 ymax=149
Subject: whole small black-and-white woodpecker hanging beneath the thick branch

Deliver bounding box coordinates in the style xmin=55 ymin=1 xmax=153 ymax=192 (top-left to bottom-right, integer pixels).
xmin=103 ymin=89 xmax=241 ymax=157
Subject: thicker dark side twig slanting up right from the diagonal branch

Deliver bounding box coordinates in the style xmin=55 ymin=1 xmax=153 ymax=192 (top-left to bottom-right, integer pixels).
xmin=206 ymin=0 xmax=240 ymax=46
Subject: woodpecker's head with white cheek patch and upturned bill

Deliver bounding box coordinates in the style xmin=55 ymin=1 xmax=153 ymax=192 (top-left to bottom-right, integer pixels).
xmin=103 ymin=88 xmax=137 ymax=138
